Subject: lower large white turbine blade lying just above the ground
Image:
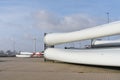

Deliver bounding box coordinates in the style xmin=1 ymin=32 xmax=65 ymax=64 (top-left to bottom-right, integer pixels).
xmin=44 ymin=48 xmax=120 ymax=67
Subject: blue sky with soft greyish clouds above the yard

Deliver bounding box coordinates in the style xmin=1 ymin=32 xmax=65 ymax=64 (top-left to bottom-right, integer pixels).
xmin=0 ymin=0 xmax=120 ymax=52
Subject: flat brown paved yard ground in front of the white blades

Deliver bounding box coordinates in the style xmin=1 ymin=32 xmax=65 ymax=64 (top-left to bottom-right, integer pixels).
xmin=0 ymin=57 xmax=120 ymax=80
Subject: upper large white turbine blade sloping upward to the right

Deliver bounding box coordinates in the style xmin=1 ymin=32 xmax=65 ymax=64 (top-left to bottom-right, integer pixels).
xmin=44 ymin=21 xmax=120 ymax=45
